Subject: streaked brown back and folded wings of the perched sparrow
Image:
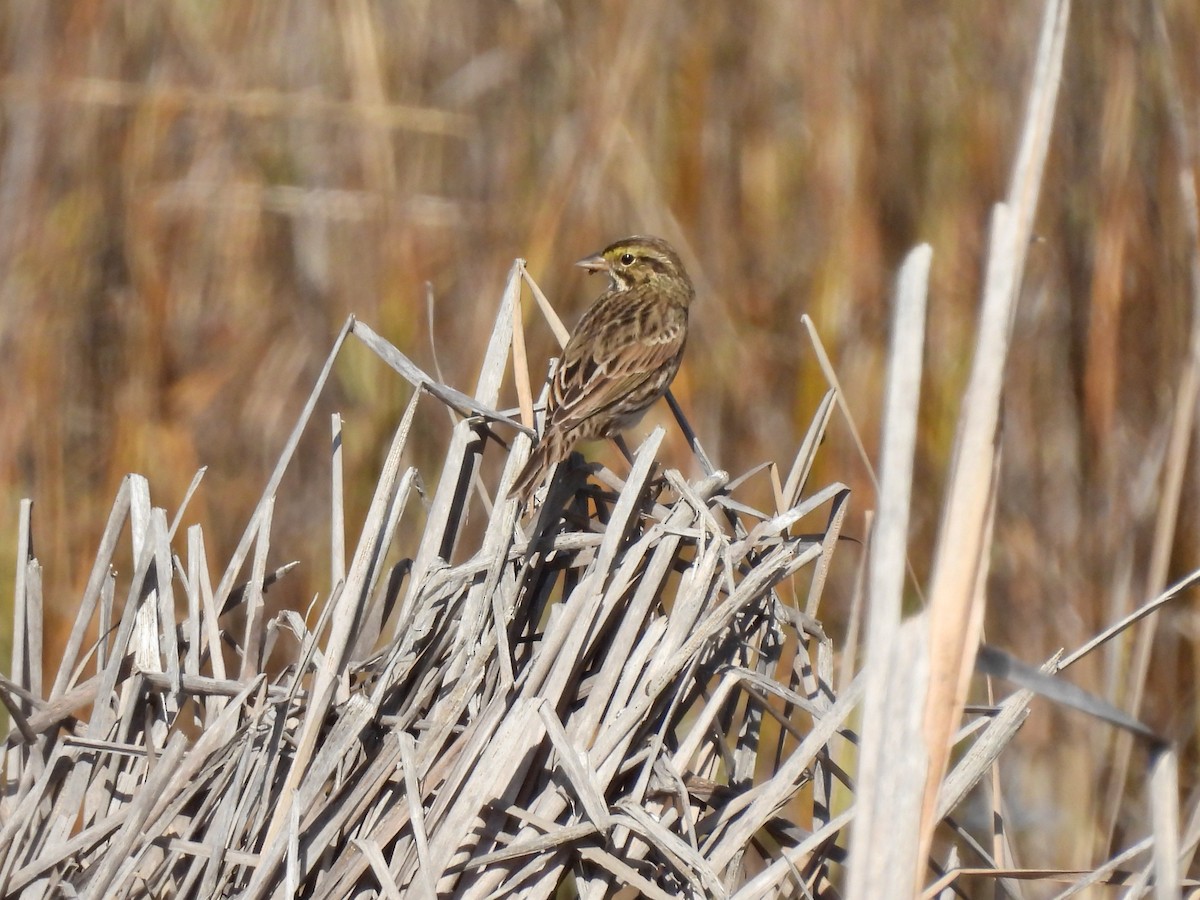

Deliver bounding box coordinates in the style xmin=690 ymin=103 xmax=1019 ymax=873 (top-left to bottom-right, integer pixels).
xmin=548 ymin=288 xmax=688 ymax=430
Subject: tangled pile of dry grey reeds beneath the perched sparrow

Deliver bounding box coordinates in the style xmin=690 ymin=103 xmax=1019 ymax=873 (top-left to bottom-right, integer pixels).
xmin=0 ymin=252 xmax=858 ymax=898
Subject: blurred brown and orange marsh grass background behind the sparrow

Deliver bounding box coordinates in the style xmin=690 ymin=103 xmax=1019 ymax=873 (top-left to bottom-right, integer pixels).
xmin=0 ymin=0 xmax=1200 ymax=888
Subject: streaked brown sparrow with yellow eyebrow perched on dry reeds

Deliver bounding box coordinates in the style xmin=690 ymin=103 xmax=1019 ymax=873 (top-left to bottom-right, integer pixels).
xmin=512 ymin=236 xmax=696 ymax=506
